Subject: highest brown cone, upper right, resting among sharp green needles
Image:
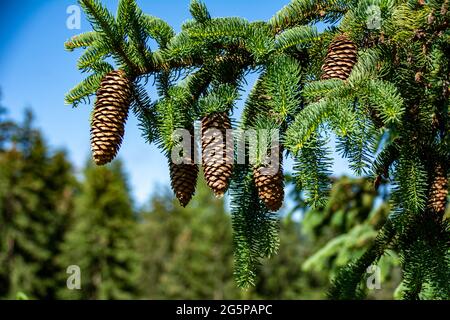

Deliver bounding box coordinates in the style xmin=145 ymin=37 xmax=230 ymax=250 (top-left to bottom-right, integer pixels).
xmin=322 ymin=34 xmax=358 ymax=80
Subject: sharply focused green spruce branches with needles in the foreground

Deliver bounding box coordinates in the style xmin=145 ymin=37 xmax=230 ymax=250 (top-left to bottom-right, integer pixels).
xmin=66 ymin=0 xmax=450 ymax=299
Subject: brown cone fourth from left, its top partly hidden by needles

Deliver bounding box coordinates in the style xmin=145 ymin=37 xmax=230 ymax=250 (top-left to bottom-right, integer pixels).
xmin=253 ymin=151 xmax=284 ymax=212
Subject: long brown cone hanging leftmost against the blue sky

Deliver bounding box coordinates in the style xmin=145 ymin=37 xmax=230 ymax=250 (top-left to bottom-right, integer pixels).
xmin=91 ymin=70 xmax=133 ymax=165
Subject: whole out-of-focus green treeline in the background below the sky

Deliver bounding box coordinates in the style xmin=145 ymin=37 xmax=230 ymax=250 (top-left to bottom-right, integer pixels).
xmin=0 ymin=104 xmax=444 ymax=299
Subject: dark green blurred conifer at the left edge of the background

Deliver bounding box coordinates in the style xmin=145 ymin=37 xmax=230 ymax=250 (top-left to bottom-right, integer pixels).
xmin=0 ymin=111 xmax=75 ymax=299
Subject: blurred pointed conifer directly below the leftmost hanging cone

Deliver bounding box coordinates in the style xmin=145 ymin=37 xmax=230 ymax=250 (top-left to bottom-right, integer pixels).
xmin=59 ymin=161 xmax=140 ymax=300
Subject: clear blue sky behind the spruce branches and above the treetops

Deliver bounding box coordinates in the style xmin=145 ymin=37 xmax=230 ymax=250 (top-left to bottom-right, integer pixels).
xmin=0 ymin=0 xmax=348 ymax=203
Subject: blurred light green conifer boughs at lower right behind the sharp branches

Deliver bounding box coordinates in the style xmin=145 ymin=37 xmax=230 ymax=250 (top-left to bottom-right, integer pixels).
xmin=302 ymin=177 xmax=400 ymax=299
